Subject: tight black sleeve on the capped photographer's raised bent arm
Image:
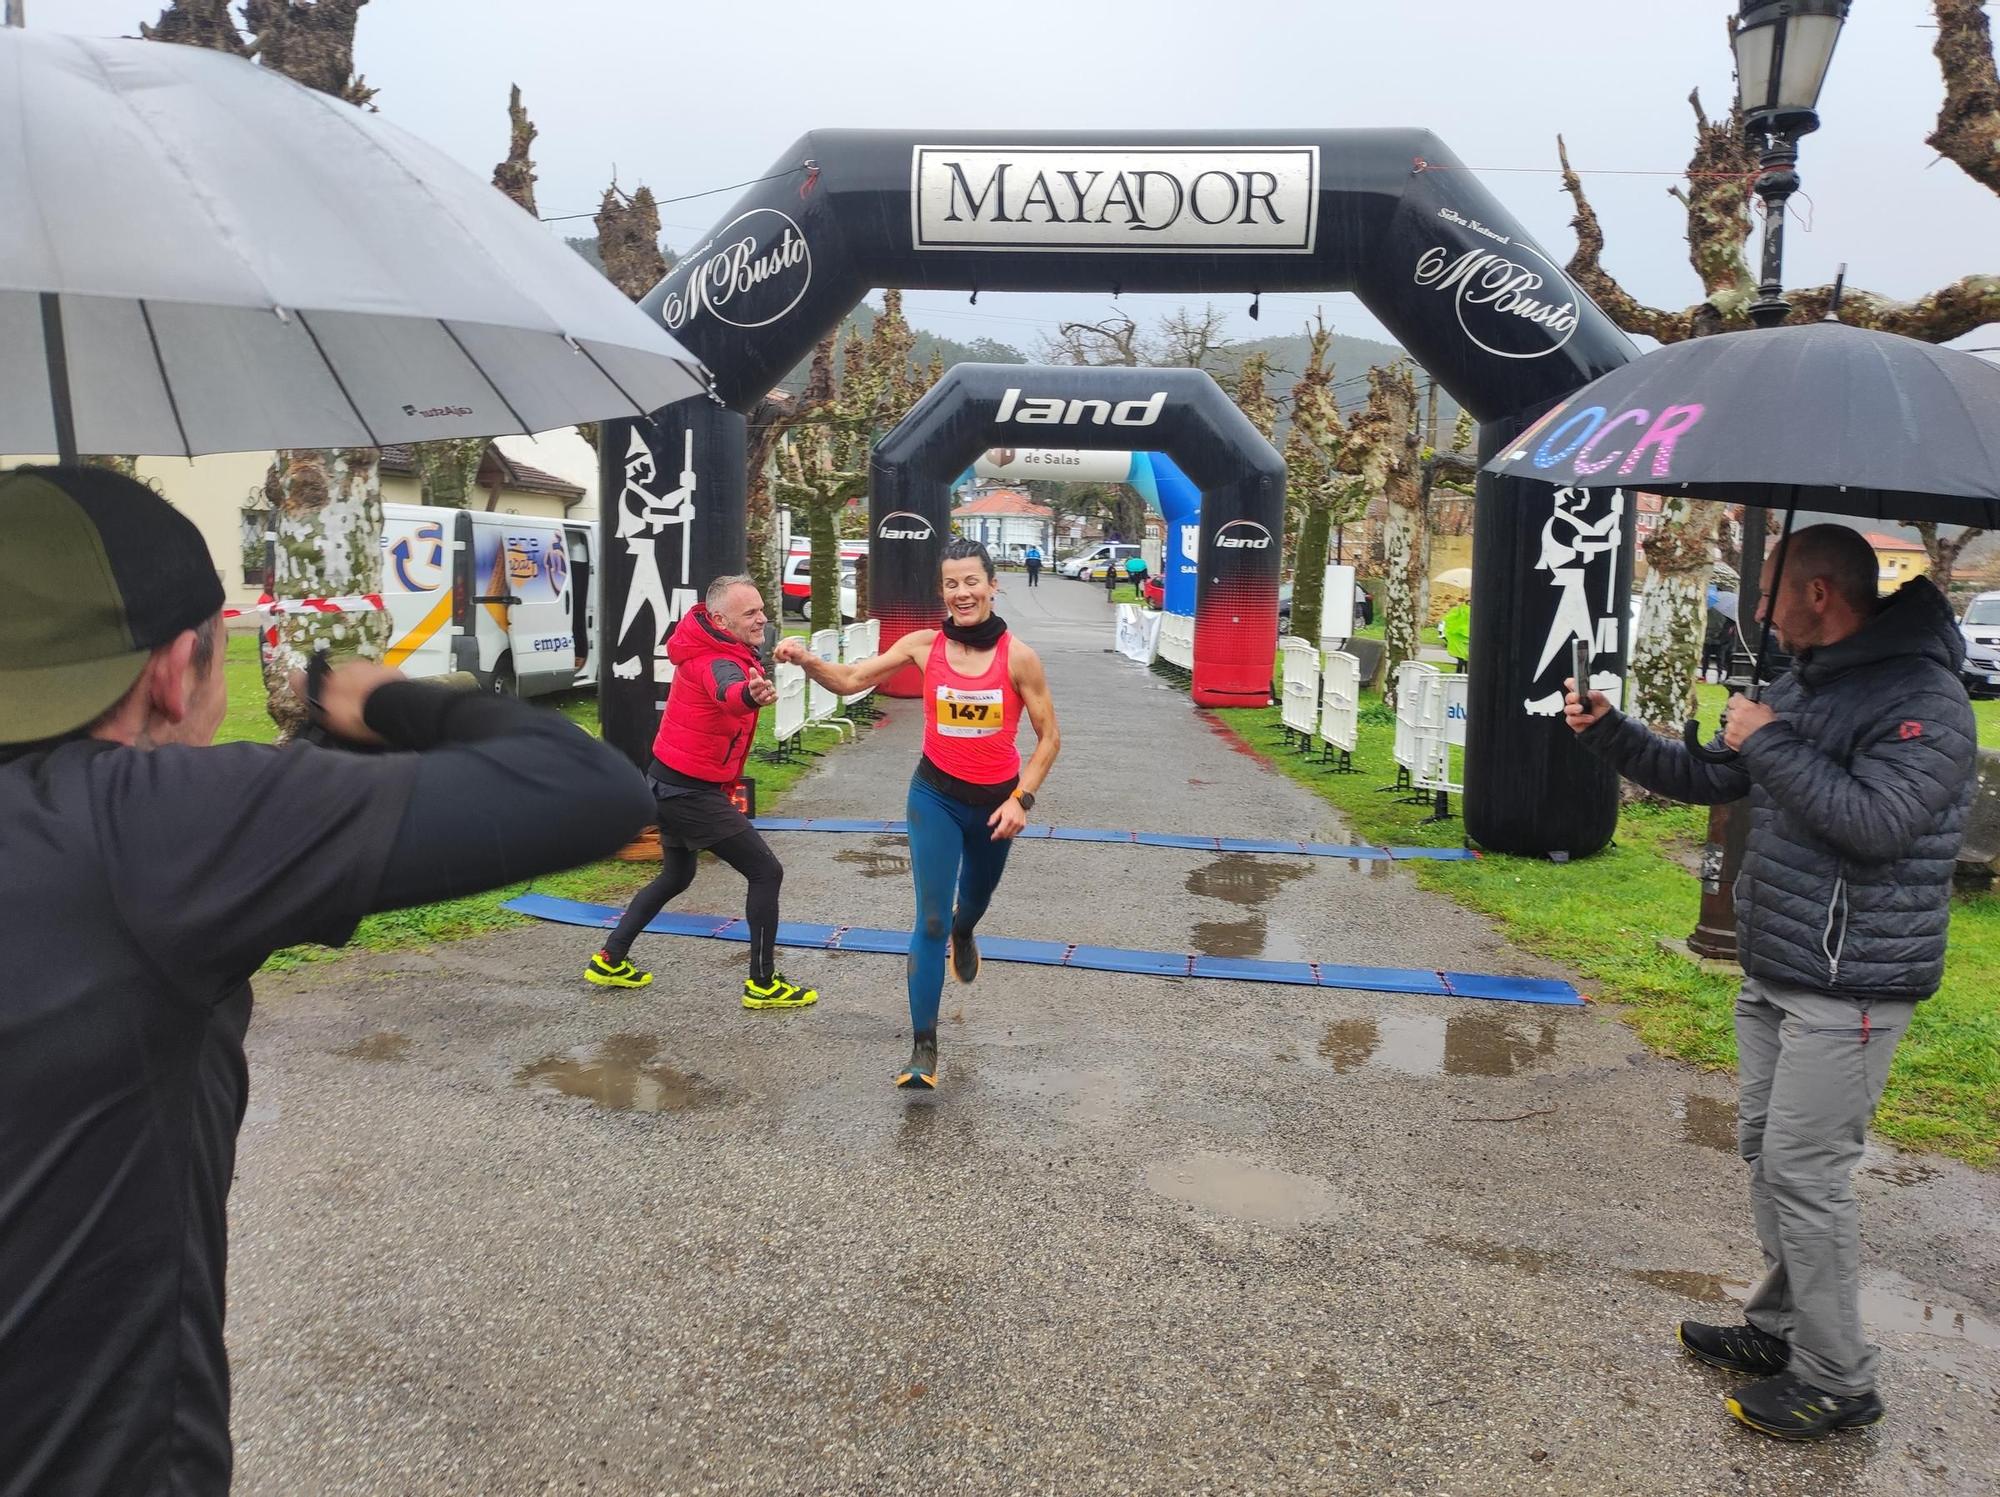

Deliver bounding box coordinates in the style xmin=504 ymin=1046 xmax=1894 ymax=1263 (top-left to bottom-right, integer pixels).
xmin=366 ymin=682 xmax=654 ymax=909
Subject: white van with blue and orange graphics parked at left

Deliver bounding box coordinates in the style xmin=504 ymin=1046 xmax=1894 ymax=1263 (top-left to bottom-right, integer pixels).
xmin=382 ymin=504 xmax=598 ymax=696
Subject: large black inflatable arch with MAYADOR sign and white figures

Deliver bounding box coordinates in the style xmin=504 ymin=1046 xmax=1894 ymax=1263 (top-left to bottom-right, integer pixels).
xmin=600 ymin=130 xmax=1634 ymax=855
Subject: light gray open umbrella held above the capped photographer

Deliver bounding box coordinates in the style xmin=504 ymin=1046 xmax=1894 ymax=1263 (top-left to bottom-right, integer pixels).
xmin=0 ymin=30 xmax=706 ymax=456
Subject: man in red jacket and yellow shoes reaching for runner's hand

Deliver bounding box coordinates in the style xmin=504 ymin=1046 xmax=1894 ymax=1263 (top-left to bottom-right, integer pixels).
xmin=584 ymin=576 xmax=820 ymax=1009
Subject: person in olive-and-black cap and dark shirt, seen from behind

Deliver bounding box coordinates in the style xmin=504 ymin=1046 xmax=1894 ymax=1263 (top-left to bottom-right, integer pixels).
xmin=0 ymin=466 xmax=652 ymax=1497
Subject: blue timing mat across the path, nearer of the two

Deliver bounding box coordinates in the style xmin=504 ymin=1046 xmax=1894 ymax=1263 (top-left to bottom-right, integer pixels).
xmin=500 ymin=895 xmax=1584 ymax=1009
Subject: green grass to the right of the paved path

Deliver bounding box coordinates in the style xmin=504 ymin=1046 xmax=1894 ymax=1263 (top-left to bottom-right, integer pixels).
xmin=1216 ymin=686 xmax=2000 ymax=1169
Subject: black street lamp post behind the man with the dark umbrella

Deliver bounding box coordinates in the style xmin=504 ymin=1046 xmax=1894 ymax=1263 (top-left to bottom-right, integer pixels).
xmin=1688 ymin=0 xmax=1850 ymax=959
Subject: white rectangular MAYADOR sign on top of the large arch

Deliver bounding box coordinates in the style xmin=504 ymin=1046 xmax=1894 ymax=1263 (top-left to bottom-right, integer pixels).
xmin=910 ymin=146 xmax=1320 ymax=254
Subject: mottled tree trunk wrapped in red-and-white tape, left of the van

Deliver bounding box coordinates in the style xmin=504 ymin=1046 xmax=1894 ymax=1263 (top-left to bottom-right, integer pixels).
xmin=264 ymin=446 xmax=388 ymax=736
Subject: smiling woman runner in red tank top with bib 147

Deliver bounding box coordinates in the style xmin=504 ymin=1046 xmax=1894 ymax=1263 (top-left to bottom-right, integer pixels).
xmin=776 ymin=540 xmax=1062 ymax=1091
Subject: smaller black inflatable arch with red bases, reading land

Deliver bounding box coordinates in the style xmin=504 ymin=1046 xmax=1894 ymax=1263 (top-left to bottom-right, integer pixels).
xmin=868 ymin=364 xmax=1284 ymax=706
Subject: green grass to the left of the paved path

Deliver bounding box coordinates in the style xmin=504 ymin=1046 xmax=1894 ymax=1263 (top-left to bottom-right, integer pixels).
xmin=216 ymin=634 xmax=852 ymax=973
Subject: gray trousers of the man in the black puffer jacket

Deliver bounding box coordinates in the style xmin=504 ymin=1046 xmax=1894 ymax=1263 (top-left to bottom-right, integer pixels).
xmin=1736 ymin=977 xmax=1916 ymax=1397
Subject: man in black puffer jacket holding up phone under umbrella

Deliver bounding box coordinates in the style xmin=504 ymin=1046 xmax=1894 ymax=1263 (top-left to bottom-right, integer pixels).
xmin=1566 ymin=524 xmax=1976 ymax=1439
